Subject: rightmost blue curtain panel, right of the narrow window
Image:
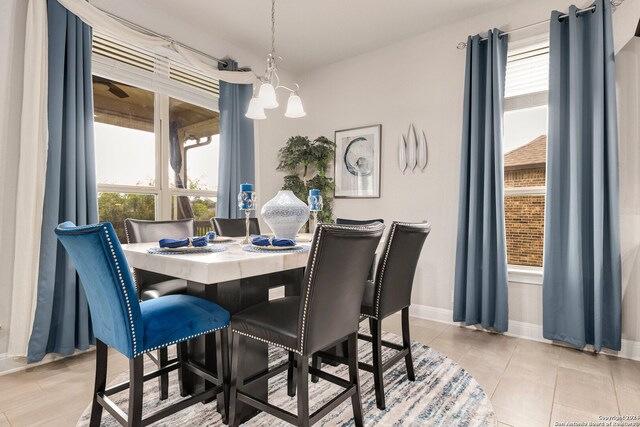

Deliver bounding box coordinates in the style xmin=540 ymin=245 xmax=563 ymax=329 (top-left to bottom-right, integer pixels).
xmin=543 ymin=0 xmax=621 ymax=351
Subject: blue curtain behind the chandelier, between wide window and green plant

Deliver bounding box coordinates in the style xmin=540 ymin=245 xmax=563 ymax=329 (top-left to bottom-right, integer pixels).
xmin=216 ymin=59 xmax=257 ymax=218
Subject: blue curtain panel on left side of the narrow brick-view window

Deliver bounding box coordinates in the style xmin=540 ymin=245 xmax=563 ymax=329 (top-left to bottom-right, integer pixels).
xmin=453 ymin=30 xmax=509 ymax=332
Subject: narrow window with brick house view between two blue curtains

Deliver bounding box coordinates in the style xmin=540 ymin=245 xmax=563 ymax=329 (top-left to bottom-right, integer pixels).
xmin=503 ymin=43 xmax=549 ymax=268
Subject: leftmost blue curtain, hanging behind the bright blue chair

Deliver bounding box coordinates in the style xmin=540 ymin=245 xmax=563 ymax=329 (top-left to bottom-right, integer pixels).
xmin=27 ymin=0 xmax=98 ymax=362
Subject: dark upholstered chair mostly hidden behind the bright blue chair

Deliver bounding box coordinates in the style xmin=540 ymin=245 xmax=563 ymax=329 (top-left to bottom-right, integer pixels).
xmin=124 ymin=218 xmax=195 ymax=400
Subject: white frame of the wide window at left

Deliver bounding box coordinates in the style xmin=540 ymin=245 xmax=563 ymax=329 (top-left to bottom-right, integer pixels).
xmin=91 ymin=33 xmax=220 ymax=220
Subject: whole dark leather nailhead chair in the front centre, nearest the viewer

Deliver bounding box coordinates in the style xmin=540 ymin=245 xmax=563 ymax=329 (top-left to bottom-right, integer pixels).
xmin=229 ymin=224 xmax=384 ymax=427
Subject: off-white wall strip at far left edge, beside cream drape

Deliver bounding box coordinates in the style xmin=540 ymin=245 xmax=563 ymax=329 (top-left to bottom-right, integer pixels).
xmin=0 ymin=0 xmax=27 ymax=354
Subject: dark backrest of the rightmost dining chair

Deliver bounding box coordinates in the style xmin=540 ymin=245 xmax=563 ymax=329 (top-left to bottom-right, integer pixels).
xmin=373 ymin=221 xmax=431 ymax=319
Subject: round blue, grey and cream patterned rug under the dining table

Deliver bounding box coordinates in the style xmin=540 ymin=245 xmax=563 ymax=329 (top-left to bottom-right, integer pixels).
xmin=77 ymin=333 xmax=497 ymax=427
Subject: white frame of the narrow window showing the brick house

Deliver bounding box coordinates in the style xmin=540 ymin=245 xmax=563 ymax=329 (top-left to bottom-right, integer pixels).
xmin=503 ymin=41 xmax=549 ymax=285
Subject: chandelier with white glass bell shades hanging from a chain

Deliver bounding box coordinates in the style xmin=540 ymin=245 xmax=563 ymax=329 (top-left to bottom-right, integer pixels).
xmin=245 ymin=0 xmax=307 ymax=120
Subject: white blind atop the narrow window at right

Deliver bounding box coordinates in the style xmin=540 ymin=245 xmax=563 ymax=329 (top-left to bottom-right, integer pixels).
xmin=505 ymin=44 xmax=549 ymax=98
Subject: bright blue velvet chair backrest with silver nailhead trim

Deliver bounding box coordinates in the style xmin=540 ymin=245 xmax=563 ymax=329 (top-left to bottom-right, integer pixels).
xmin=55 ymin=221 xmax=143 ymax=358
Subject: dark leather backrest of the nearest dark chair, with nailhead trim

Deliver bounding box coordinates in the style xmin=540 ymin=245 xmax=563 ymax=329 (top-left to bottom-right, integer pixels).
xmin=298 ymin=223 xmax=384 ymax=355
